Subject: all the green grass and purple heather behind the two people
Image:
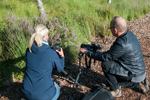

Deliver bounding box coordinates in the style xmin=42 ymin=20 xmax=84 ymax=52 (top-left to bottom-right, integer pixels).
xmin=0 ymin=0 xmax=150 ymax=85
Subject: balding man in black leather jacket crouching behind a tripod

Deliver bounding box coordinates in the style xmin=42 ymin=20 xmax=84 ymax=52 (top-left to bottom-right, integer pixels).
xmin=80 ymin=16 xmax=149 ymax=97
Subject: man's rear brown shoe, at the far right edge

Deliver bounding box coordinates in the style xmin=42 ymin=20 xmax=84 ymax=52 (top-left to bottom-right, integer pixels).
xmin=140 ymin=78 xmax=149 ymax=94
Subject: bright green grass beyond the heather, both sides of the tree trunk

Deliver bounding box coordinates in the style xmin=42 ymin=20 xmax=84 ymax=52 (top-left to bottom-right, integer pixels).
xmin=0 ymin=0 xmax=150 ymax=42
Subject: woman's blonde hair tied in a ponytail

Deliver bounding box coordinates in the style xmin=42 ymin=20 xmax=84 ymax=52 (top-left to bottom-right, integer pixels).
xmin=29 ymin=24 xmax=49 ymax=52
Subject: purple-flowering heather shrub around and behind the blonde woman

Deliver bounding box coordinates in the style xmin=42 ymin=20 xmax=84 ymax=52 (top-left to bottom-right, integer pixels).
xmin=0 ymin=15 xmax=75 ymax=84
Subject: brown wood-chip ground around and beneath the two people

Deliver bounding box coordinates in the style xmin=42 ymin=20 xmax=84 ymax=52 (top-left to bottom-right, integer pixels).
xmin=0 ymin=13 xmax=150 ymax=100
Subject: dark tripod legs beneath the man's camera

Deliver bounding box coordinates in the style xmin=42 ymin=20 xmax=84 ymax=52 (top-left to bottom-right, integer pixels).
xmin=69 ymin=52 xmax=106 ymax=100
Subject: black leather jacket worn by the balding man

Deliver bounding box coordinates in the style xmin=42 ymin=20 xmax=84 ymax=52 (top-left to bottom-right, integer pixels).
xmin=88 ymin=31 xmax=145 ymax=77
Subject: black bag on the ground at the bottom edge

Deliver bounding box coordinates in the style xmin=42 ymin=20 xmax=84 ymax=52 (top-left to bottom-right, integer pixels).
xmin=82 ymin=86 xmax=114 ymax=100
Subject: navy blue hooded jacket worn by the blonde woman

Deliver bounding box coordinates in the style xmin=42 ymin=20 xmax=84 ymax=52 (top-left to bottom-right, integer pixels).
xmin=22 ymin=43 xmax=64 ymax=100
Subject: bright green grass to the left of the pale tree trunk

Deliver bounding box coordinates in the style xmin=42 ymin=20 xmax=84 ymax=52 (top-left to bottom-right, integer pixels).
xmin=0 ymin=0 xmax=38 ymax=21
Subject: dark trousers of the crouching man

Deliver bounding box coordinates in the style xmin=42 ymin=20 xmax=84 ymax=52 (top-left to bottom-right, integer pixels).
xmin=102 ymin=61 xmax=139 ymax=91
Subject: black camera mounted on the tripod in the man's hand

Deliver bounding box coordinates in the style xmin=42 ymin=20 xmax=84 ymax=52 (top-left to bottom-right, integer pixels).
xmin=81 ymin=44 xmax=101 ymax=52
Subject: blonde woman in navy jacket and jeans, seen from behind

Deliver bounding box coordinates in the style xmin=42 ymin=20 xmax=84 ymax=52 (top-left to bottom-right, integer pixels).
xmin=22 ymin=24 xmax=64 ymax=100
